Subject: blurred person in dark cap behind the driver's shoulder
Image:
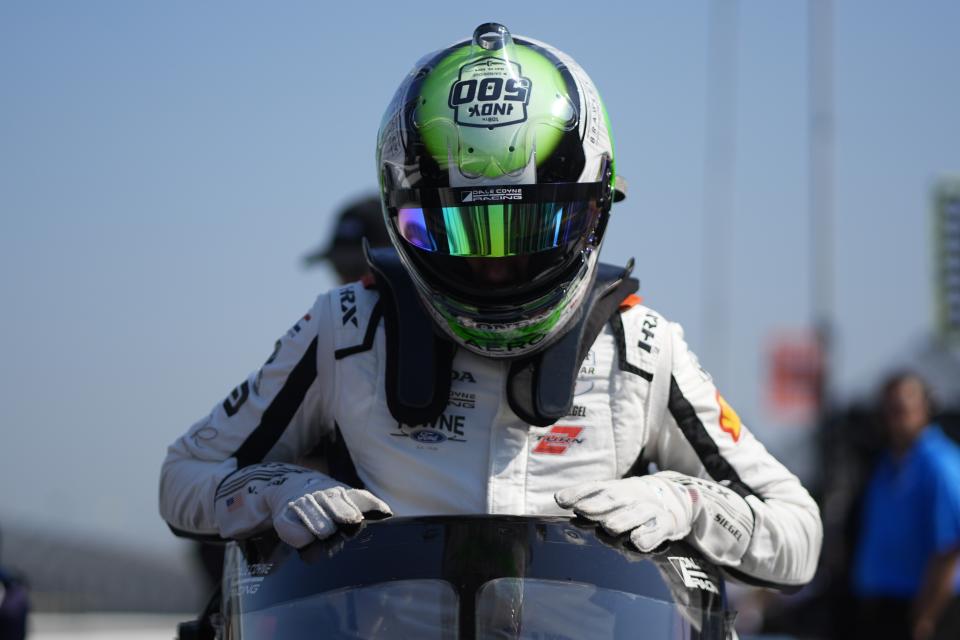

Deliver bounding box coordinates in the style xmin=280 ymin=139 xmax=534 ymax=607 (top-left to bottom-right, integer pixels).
xmin=303 ymin=194 xmax=390 ymax=283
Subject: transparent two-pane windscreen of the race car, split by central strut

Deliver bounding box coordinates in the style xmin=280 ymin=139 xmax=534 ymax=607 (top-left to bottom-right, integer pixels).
xmin=227 ymin=578 xmax=723 ymax=640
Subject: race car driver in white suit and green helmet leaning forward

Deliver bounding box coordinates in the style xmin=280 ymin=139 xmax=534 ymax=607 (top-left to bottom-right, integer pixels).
xmin=160 ymin=23 xmax=822 ymax=586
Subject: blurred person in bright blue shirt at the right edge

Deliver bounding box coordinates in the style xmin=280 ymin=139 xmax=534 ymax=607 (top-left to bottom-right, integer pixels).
xmin=853 ymin=373 xmax=960 ymax=640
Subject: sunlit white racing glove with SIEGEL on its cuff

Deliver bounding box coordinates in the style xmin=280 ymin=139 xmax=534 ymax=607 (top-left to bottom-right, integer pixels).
xmin=554 ymin=471 xmax=753 ymax=566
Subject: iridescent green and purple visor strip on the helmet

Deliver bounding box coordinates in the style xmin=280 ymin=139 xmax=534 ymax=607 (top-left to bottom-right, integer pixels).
xmin=396 ymin=202 xmax=597 ymax=258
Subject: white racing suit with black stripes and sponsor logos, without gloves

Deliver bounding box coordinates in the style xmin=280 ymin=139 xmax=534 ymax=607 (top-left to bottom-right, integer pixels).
xmin=160 ymin=283 xmax=822 ymax=586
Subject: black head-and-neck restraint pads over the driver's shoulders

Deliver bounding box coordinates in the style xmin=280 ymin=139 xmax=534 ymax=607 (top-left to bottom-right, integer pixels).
xmin=365 ymin=246 xmax=640 ymax=427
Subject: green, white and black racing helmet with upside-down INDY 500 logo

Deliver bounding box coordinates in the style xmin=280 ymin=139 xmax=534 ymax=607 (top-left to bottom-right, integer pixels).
xmin=377 ymin=23 xmax=614 ymax=358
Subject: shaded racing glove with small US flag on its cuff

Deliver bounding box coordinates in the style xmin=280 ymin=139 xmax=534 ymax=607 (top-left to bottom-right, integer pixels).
xmin=214 ymin=463 xmax=393 ymax=549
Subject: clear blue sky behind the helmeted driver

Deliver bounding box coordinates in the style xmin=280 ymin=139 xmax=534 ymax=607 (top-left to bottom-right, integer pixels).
xmin=0 ymin=0 xmax=960 ymax=547
